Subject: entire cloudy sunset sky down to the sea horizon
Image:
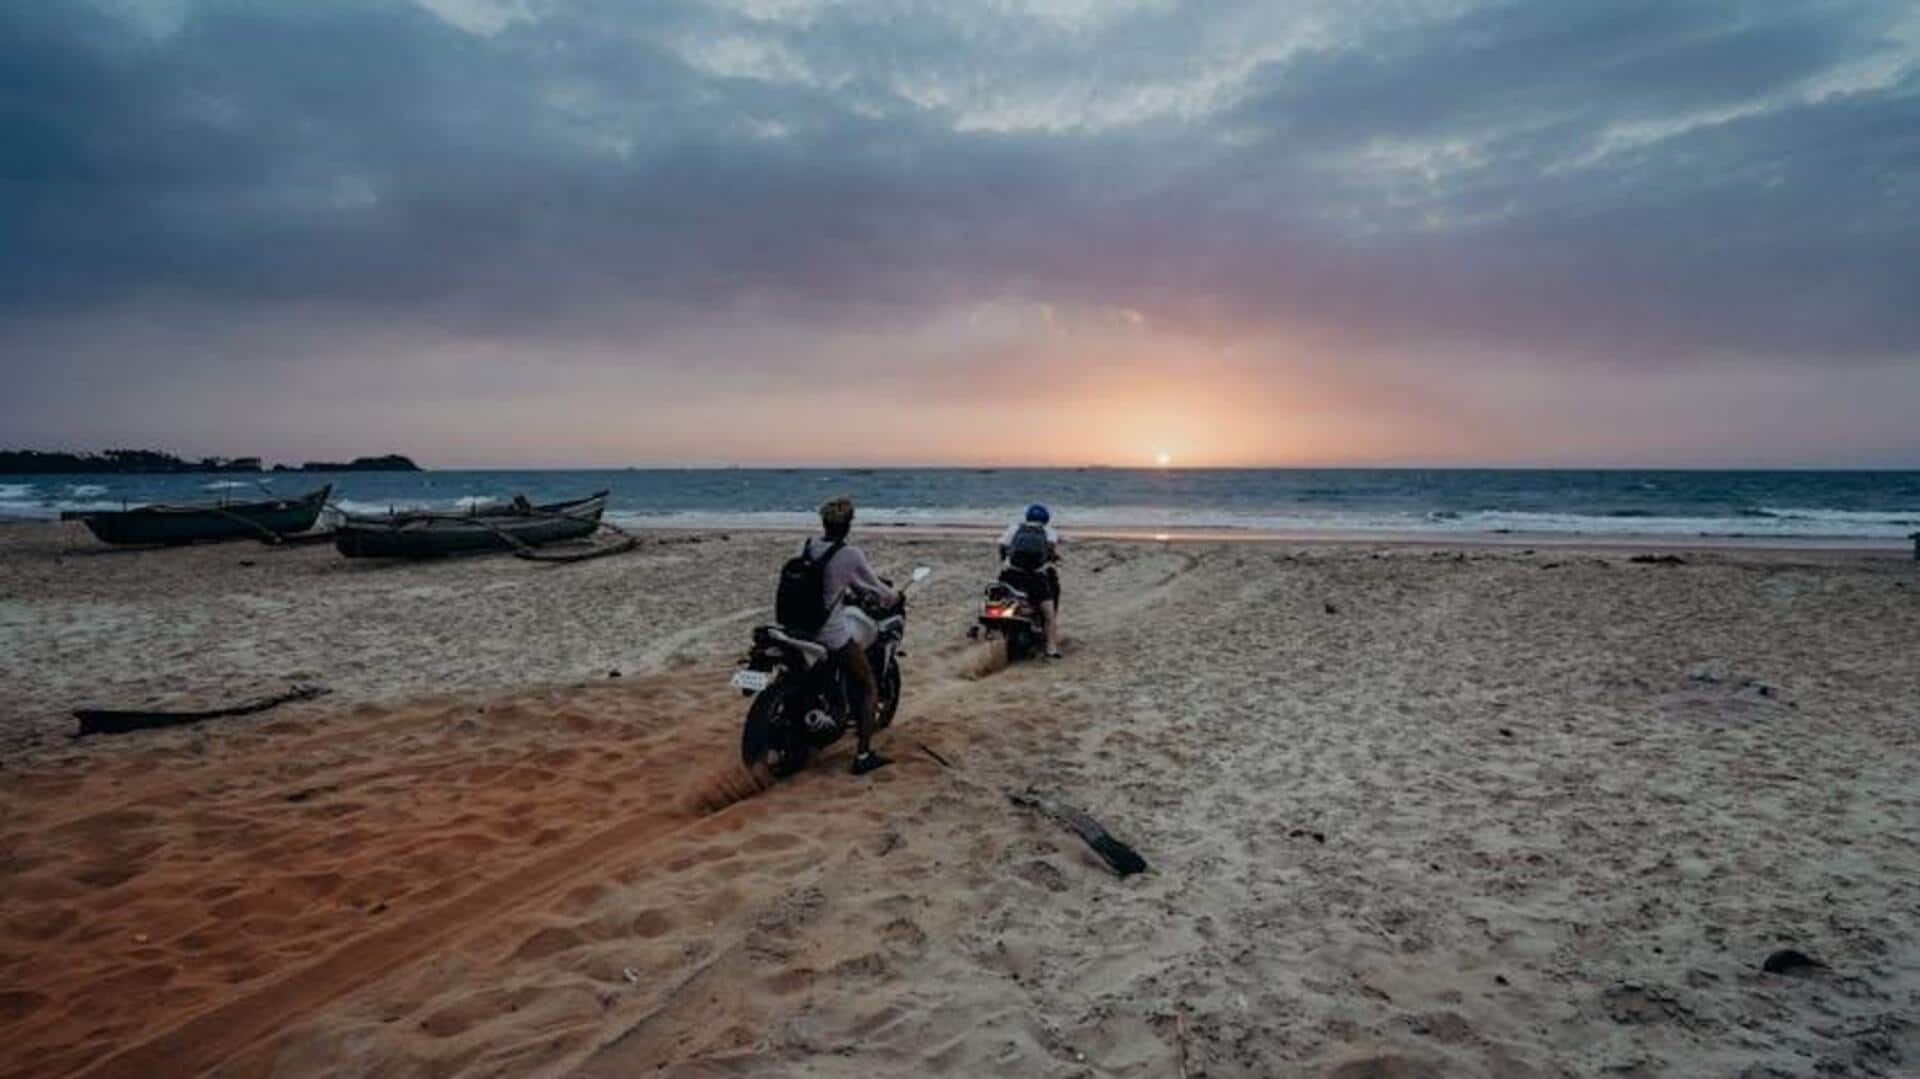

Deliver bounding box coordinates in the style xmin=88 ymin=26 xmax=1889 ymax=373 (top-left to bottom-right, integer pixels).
xmin=0 ymin=0 xmax=1920 ymax=467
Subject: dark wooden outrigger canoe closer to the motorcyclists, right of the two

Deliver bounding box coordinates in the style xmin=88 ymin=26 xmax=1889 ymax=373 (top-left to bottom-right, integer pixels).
xmin=334 ymin=492 xmax=607 ymax=559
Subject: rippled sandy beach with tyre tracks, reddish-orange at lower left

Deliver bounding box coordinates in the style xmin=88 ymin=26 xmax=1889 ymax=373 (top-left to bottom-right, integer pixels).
xmin=0 ymin=524 xmax=1920 ymax=1077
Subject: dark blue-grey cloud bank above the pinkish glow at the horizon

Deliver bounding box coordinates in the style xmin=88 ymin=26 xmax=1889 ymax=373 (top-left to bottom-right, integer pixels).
xmin=0 ymin=0 xmax=1920 ymax=456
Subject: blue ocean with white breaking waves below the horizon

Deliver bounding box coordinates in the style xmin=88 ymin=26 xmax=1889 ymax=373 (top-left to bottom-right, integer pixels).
xmin=0 ymin=468 xmax=1920 ymax=545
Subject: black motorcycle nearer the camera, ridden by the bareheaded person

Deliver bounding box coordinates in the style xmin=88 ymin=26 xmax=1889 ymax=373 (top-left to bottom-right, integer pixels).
xmin=732 ymin=566 xmax=933 ymax=778
